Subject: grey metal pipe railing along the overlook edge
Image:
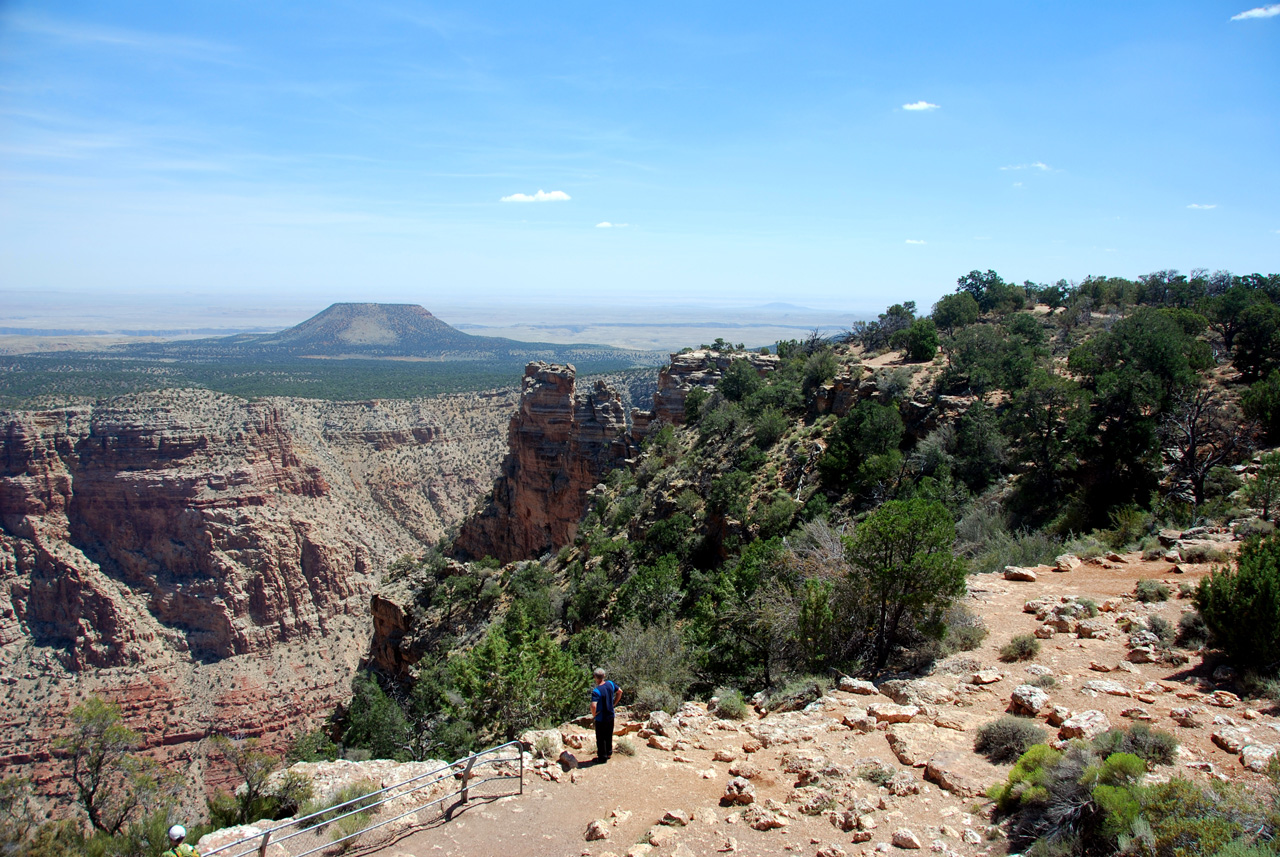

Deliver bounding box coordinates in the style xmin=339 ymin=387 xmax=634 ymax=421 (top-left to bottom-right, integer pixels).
xmin=205 ymin=741 xmax=525 ymax=857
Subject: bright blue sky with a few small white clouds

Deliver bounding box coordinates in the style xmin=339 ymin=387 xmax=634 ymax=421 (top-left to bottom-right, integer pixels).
xmin=0 ymin=0 xmax=1280 ymax=317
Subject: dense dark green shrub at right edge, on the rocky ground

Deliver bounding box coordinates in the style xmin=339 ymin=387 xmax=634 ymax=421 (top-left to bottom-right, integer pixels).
xmin=1196 ymin=536 xmax=1280 ymax=670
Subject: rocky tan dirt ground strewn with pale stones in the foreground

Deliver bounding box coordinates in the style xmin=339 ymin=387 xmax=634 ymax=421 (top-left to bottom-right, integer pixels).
xmin=212 ymin=532 xmax=1280 ymax=857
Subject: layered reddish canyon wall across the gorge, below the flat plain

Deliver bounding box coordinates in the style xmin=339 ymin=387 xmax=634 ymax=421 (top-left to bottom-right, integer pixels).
xmin=0 ymin=390 xmax=515 ymax=813
